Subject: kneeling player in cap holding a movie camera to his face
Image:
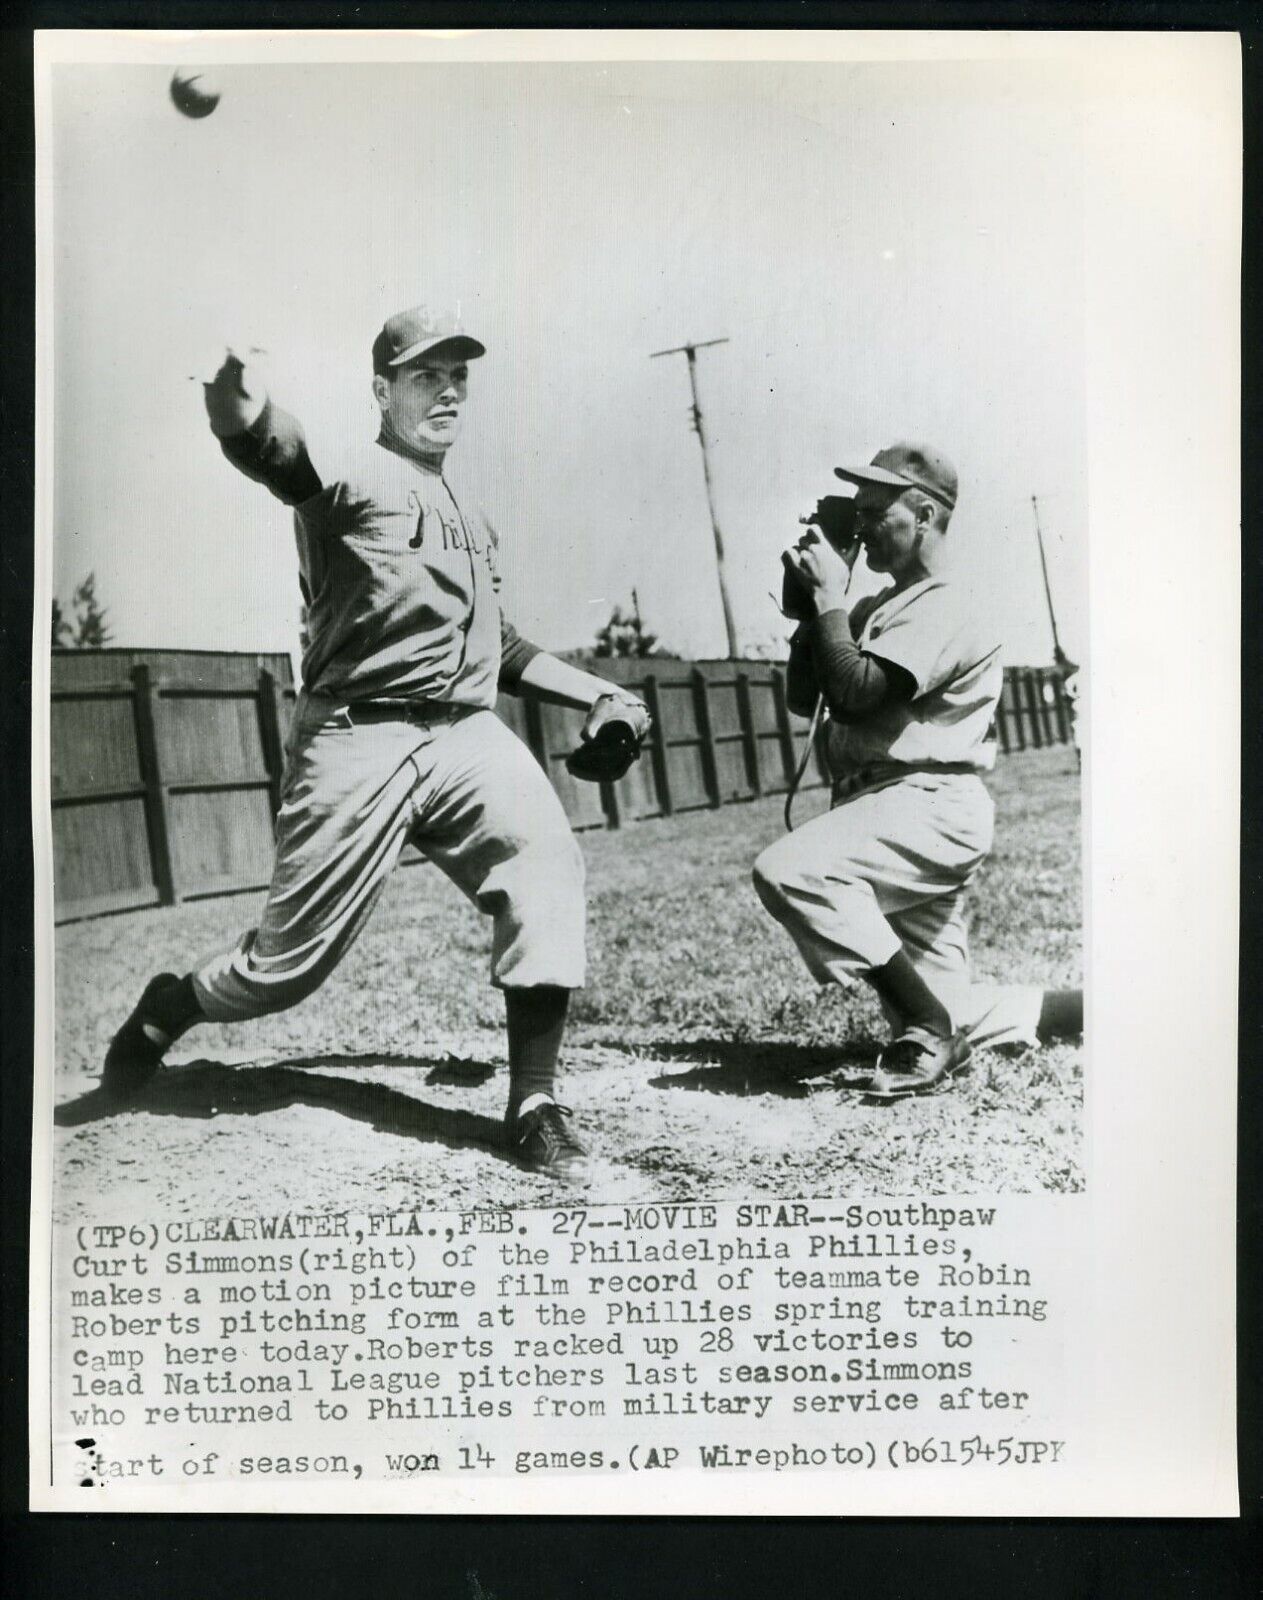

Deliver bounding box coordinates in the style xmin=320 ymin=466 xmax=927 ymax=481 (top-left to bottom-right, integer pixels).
xmin=754 ymin=443 xmax=1082 ymax=1101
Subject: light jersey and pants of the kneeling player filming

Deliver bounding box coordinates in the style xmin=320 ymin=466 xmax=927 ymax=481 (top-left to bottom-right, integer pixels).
xmin=754 ymin=578 xmax=1042 ymax=1048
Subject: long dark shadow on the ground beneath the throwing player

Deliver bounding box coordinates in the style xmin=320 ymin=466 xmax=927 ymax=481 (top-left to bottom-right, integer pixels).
xmin=53 ymin=1056 xmax=507 ymax=1158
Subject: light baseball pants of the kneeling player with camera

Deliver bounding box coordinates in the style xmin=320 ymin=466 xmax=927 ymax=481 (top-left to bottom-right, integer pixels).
xmin=754 ymin=773 xmax=1044 ymax=1050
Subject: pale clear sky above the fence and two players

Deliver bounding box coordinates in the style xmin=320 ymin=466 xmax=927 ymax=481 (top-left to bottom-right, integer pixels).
xmin=45 ymin=62 xmax=1089 ymax=664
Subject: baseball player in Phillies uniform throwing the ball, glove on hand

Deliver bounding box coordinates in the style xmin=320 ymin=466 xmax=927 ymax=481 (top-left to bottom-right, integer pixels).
xmin=101 ymin=307 xmax=648 ymax=1178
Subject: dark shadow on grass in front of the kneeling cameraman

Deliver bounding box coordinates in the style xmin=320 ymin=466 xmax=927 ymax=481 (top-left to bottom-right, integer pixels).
xmin=630 ymin=1038 xmax=877 ymax=1099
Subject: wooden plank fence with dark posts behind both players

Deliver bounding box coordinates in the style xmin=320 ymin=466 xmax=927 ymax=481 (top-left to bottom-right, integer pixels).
xmin=51 ymin=650 xmax=1071 ymax=922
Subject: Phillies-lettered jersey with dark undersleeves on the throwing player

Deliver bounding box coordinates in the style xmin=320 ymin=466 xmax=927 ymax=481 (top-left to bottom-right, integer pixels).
xmin=221 ymin=402 xmax=538 ymax=709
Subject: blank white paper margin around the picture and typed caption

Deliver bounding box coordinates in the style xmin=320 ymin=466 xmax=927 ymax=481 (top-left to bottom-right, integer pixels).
xmin=30 ymin=29 xmax=1241 ymax=1517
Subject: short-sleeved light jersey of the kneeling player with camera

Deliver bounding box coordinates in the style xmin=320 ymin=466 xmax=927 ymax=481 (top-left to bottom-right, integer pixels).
xmin=826 ymin=578 xmax=1004 ymax=776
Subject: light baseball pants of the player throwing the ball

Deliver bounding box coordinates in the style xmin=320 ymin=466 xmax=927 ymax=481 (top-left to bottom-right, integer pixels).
xmin=194 ymin=696 xmax=584 ymax=1022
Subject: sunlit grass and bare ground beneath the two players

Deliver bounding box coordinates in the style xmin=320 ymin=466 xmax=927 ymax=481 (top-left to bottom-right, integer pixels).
xmin=56 ymin=749 xmax=1082 ymax=1219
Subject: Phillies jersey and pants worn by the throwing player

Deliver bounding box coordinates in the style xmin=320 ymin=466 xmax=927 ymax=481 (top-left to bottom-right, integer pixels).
xmin=194 ymin=403 xmax=584 ymax=1022
